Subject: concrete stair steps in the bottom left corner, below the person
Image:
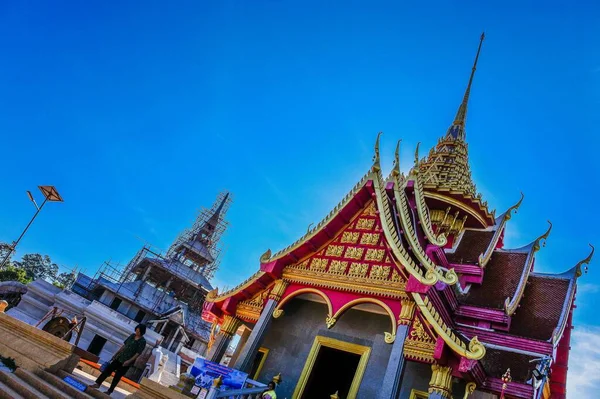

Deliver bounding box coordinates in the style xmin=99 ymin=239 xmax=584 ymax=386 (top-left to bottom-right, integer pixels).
xmin=0 ymin=368 xmax=110 ymax=399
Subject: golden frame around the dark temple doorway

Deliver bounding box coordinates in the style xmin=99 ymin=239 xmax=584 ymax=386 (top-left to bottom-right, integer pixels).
xmin=292 ymin=335 xmax=371 ymax=399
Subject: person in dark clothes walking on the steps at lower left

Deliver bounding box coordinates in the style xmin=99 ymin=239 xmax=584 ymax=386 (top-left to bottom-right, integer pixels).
xmin=91 ymin=324 xmax=146 ymax=395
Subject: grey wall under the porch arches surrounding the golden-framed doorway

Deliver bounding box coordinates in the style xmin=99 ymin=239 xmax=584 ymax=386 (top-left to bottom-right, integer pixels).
xmin=258 ymin=299 xmax=392 ymax=399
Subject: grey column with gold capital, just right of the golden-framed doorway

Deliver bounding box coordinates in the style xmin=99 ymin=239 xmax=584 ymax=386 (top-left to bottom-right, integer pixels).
xmin=377 ymin=300 xmax=415 ymax=399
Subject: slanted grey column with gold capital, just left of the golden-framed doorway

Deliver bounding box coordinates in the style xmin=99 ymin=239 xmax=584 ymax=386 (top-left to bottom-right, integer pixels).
xmin=233 ymin=280 xmax=288 ymax=372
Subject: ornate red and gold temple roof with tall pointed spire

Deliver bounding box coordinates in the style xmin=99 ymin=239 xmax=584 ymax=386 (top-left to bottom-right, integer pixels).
xmin=203 ymin=35 xmax=591 ymax=397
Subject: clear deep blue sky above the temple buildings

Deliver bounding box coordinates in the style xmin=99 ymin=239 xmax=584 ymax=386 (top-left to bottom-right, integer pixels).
xmin=0 ymin=1 xmax=600 ymax=396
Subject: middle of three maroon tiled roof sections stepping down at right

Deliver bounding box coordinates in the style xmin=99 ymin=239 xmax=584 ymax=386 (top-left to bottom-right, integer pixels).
xmin=458 ymin=251 xmax=528 ymax=309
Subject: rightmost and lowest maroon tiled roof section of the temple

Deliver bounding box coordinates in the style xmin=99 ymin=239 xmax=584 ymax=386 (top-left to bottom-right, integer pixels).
xmin=510 ymin=274 xmax=570 ymax=341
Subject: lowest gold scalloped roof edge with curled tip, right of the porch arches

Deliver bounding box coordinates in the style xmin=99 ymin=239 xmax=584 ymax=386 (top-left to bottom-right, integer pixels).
xmin=412 ymin=292 xmax=485 ymax=360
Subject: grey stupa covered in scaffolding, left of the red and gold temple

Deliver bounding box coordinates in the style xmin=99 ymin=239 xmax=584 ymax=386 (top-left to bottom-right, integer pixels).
xmin=8 ymin=192 xmax=232 ymax=386
